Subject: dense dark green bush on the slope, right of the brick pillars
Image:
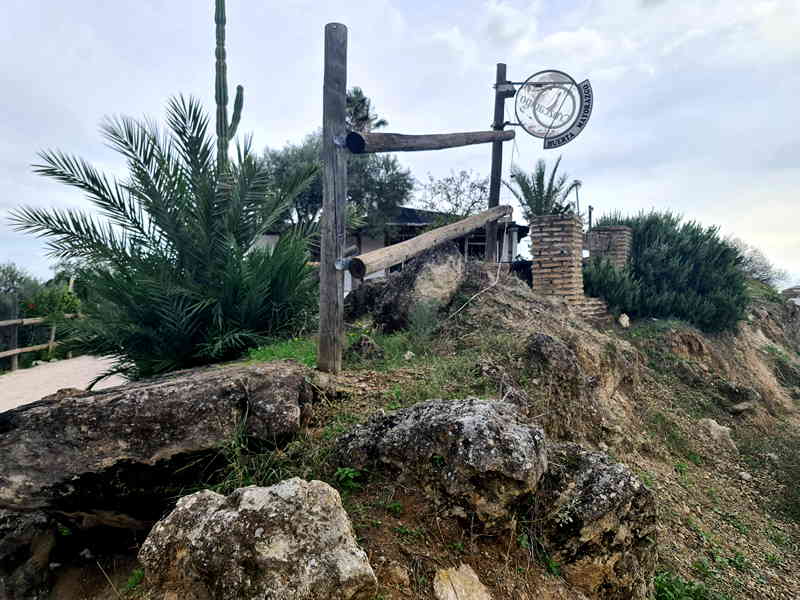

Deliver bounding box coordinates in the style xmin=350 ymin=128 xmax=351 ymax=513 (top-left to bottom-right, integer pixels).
xmin=588 ymin=211 xmax=748 ymax=332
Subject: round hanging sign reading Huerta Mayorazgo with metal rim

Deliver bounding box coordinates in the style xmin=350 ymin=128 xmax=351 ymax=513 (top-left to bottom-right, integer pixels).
xmin=514 ymin=70 xmax=593 ymax=148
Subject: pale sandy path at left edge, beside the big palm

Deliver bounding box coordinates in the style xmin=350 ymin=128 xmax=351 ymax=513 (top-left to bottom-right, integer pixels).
xmin=0 ymin=356 xmax=125 ymax=412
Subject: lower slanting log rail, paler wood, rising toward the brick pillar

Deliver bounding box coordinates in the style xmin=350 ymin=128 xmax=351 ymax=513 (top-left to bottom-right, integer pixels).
xmin=348 ymin=206 xmax=512 ymax=279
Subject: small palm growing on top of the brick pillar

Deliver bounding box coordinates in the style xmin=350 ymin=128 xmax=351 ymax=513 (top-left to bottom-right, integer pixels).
xmin=503 ymin=156 xmax=581 ymax=221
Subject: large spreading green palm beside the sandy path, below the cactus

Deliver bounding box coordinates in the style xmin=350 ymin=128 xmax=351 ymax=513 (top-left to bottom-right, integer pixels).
xmin=12 ymin=97 xmax=314 ymax=378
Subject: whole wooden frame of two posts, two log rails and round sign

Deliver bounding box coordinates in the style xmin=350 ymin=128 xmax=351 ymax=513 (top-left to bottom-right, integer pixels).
xmin=317 ymin=23 xmax=591 ymax=373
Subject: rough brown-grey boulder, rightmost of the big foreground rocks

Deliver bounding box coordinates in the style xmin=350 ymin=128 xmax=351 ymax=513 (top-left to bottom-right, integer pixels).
xmin=533 ymin=444 xmax=657 ymax=600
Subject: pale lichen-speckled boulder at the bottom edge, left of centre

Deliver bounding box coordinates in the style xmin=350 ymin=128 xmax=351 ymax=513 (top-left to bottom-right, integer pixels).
xmin=139 ymin=478 xmax=377 ymax=600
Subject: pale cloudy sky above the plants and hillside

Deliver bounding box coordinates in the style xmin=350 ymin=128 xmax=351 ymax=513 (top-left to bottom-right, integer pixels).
xmin=0 ymin=0 xmax=800 ymax=283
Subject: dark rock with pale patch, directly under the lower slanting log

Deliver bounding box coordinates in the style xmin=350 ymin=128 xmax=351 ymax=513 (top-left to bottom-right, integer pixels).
xmin=345 ymin=244 xmax=465 ymax=332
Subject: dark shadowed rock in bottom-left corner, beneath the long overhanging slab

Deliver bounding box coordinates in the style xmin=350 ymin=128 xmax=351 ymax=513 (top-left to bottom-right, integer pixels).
xmin=0 ymin=509 xmax=55 ymax=600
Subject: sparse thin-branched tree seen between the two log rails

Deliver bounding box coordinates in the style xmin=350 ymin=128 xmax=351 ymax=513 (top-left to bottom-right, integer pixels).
xmin=420 ymin=170 xmax=489 ymax=227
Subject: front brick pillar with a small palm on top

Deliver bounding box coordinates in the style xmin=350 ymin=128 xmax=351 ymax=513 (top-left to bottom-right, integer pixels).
xmin=530 ymin=215 xmax=583 ymax=302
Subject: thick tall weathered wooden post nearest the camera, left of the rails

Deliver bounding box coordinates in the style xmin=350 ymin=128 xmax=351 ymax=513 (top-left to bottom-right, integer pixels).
xmin=317 ymin=23 xmax=347 ymax=373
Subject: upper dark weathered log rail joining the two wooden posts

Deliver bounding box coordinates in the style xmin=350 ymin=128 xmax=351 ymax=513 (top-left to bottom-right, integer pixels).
xmin=345 ymin=130 xmax=514 ymax=154
